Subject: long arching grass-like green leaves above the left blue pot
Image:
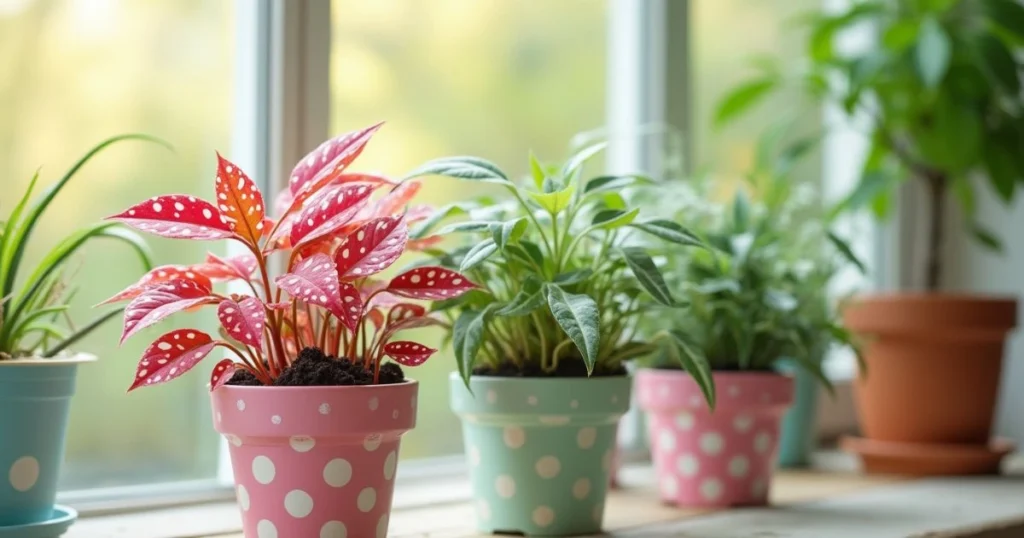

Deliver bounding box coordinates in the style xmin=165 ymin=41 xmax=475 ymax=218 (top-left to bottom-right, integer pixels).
xmin=0 ymin=134 xmax=157 ymax=360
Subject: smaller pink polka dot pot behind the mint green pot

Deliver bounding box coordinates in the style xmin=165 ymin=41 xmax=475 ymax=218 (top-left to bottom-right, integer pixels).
xmin=636 ymin=370 xmax=794 ymax=507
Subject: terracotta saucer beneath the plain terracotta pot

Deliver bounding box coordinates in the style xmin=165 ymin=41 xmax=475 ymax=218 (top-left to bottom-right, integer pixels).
xmin=840 ymin=437 xmax=1015 ymax=477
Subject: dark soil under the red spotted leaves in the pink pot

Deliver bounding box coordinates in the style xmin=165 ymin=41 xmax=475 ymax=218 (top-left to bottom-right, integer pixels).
xmin=227 ymin=347 xmax=406 ymax=386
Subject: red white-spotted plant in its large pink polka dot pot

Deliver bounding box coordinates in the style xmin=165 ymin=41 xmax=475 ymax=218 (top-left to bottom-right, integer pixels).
xmin=104 ymin=125 xmax=475 ymax=538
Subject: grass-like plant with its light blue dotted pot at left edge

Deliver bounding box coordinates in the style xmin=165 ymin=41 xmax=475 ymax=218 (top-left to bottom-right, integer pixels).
xmin=0 ymin=134 xmax=154 ymax=536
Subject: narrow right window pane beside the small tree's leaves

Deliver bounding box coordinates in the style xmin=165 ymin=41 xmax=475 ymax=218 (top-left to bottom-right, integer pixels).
xmin=689 ymin=0 xmax=821 ymax=185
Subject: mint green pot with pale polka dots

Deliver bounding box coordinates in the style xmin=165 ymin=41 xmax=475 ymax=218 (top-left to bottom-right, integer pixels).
xmin=450 ymin=373 xmax=631 ymax=536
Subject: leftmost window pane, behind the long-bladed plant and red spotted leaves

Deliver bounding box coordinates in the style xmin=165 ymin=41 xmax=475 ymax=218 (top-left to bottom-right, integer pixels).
xmin=0 ymin=0 xmax=233 ymax=490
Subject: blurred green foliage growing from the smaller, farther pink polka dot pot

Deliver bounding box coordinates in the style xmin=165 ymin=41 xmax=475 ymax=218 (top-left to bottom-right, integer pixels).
xmin=644 ymin=129 xmax=863 ymax=387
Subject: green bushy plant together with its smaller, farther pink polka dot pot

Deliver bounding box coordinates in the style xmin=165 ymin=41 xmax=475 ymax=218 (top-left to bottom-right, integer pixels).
xmin=636 ymin=170 xmax=853 ymax=507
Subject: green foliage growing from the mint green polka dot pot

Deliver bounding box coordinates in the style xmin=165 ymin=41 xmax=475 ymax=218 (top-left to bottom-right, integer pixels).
xmin=409 ymin=143 xmax=715 ymax=405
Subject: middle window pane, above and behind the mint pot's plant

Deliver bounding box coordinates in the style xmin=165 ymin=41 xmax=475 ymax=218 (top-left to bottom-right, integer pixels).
xmin=331 ymin=0 xmax=606 ymax=458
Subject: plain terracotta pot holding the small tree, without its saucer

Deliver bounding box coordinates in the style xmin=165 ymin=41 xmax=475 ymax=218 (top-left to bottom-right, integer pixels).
xmin=844 ymin=294 xmax=1017 ymax=445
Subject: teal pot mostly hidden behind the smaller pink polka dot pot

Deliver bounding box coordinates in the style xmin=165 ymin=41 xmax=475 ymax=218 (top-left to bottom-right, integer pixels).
xmin=778 ymin=365 xmax=818 ymax=467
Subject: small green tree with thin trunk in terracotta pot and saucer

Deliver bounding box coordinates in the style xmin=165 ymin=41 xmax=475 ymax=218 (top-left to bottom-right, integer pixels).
xmin=720 ymin=0 xmax=1024 ymax=473
